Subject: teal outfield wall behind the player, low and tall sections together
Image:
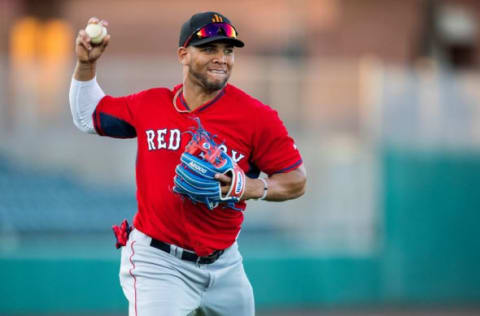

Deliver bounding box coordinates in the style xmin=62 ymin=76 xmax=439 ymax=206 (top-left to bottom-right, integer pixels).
xmin=0 ymin=148 xmax=480 ymax=314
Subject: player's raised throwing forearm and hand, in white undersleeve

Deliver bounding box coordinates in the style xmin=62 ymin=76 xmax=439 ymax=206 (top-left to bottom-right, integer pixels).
xmin=69 ymin=18 xmax=110 ymax=134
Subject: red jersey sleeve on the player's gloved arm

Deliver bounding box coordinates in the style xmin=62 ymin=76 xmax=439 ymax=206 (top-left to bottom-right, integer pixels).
xmin=251 ymin=106 xmax=303 ymax=175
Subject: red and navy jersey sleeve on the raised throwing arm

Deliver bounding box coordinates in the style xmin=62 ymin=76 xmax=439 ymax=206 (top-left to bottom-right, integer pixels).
xmin=92 ymin=92 xmax=142 ymax=138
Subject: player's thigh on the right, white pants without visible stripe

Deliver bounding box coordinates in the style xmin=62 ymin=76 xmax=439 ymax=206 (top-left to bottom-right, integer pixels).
xmin=202 ymin=263 xmax=255 ymax=316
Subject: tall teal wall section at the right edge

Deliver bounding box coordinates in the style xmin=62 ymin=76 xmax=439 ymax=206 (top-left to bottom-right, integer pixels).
xmin=379 ymin=149 xmax=480 ymax=302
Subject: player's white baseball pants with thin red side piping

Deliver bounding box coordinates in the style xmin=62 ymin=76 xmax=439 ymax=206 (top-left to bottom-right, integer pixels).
xmin=120 ymin=229 xmax=255 ymax=316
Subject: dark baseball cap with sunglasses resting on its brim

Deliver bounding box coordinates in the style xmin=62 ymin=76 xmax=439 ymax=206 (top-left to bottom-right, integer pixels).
xmin=178 ymin=12 xmax=245 ymax=47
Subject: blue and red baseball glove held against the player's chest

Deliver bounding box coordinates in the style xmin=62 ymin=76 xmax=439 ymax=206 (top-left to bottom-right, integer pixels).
xmin=173 ymin=118 xmax=245 ymax=210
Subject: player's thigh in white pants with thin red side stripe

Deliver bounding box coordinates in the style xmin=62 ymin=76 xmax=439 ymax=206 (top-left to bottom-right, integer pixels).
xmin=120 ymin=242 xmax=200 ymax=316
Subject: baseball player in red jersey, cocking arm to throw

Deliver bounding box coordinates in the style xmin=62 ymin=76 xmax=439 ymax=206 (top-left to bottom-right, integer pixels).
xmin=70 ymin=12 xmax=306 ymax=316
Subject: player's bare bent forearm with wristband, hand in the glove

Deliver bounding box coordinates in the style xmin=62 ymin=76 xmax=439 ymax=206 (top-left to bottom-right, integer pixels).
xmin=216 ymin=164 xmax=307 ymax=202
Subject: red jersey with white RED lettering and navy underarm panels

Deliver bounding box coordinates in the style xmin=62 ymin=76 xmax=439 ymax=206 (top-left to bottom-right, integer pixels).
xmin=93 ymin=84 xmax=302 ymax=256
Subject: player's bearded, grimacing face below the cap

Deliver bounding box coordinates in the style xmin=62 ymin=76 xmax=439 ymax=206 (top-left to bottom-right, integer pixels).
xmin=186 ymin=42 xmax=235 ymax=92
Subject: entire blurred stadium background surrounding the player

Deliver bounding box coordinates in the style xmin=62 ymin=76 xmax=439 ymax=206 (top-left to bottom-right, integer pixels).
xmin=0 ymin=0 xmax=480 ymax=315
